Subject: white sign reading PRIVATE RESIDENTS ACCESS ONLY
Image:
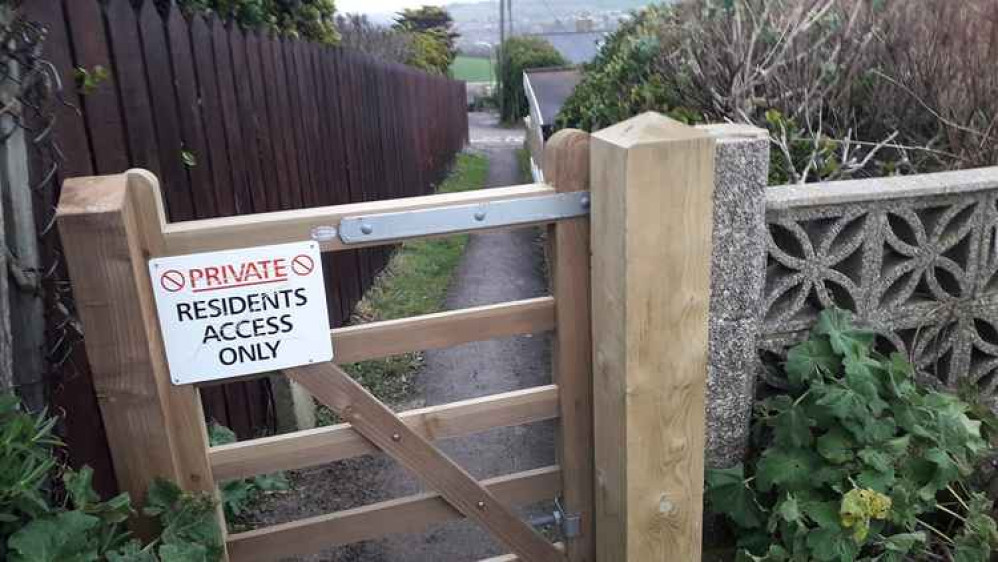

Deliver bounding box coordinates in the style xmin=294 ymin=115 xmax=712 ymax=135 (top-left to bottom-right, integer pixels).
xmin=149 ymin=242 xmax=333 ymax=384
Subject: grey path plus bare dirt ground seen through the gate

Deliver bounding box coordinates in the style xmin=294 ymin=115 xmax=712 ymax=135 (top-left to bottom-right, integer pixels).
xmin=240 ymin=113 xmax=554 ymax=562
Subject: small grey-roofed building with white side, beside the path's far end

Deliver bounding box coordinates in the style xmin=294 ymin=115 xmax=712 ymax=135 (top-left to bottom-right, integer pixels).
xmin=523 ymin=68 xmax=582 ymax=181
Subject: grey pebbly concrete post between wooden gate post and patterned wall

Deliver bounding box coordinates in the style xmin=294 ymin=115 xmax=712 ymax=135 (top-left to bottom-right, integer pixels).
xmin=702 ymin=124 xmax=769 ymax=468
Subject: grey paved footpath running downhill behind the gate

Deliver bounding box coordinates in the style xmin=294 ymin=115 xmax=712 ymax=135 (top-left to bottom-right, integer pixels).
xmin=372 ymin=113 xmax=554 ymax=562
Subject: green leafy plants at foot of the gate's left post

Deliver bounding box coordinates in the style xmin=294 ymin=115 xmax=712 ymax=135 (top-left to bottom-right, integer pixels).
xmin=0 ymin=395 xmax=223 ymax=562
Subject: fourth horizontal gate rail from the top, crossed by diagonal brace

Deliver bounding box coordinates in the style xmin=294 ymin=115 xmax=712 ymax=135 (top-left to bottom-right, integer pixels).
xmin=228 ymin=466 xmax=561 ymax=562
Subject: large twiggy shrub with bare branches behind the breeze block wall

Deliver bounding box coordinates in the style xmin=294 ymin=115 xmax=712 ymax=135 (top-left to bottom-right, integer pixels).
xmin=558 ymin=0 xmax=998 ymax=183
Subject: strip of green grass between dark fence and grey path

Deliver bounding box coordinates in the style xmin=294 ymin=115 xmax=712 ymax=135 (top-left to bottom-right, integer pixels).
xmin=317 ymin=154 xmax=489 ymax=425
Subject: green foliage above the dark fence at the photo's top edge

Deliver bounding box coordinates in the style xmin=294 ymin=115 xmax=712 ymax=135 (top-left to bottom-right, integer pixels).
xmin=174 ymin=0 xmax=340 ymax=44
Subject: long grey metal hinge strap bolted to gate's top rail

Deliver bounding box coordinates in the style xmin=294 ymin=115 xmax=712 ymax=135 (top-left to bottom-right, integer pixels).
xmin=336 ymin=191 xmax=589 ymax=245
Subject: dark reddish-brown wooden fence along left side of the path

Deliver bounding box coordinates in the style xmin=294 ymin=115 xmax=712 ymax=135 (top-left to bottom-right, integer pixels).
xmin=24 ymin=0 xmax=467 ymax=490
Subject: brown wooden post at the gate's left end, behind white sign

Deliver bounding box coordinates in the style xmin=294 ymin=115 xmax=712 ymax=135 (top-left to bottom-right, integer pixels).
xmin=57 ymin=170 xmax=225 ymax=534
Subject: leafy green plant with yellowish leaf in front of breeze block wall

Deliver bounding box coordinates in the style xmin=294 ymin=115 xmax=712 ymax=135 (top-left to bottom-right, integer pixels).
xmin=707 ymin=310 xmax=998 ymax=562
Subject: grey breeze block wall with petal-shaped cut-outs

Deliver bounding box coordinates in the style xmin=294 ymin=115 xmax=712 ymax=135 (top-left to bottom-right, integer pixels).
xmin=759 ymin=168 xmax=998 ymax=401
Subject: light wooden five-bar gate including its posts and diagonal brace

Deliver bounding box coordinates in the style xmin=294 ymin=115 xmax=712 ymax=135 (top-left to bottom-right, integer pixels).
xmin=59 ymin=114 xmax=713 ymax=562
